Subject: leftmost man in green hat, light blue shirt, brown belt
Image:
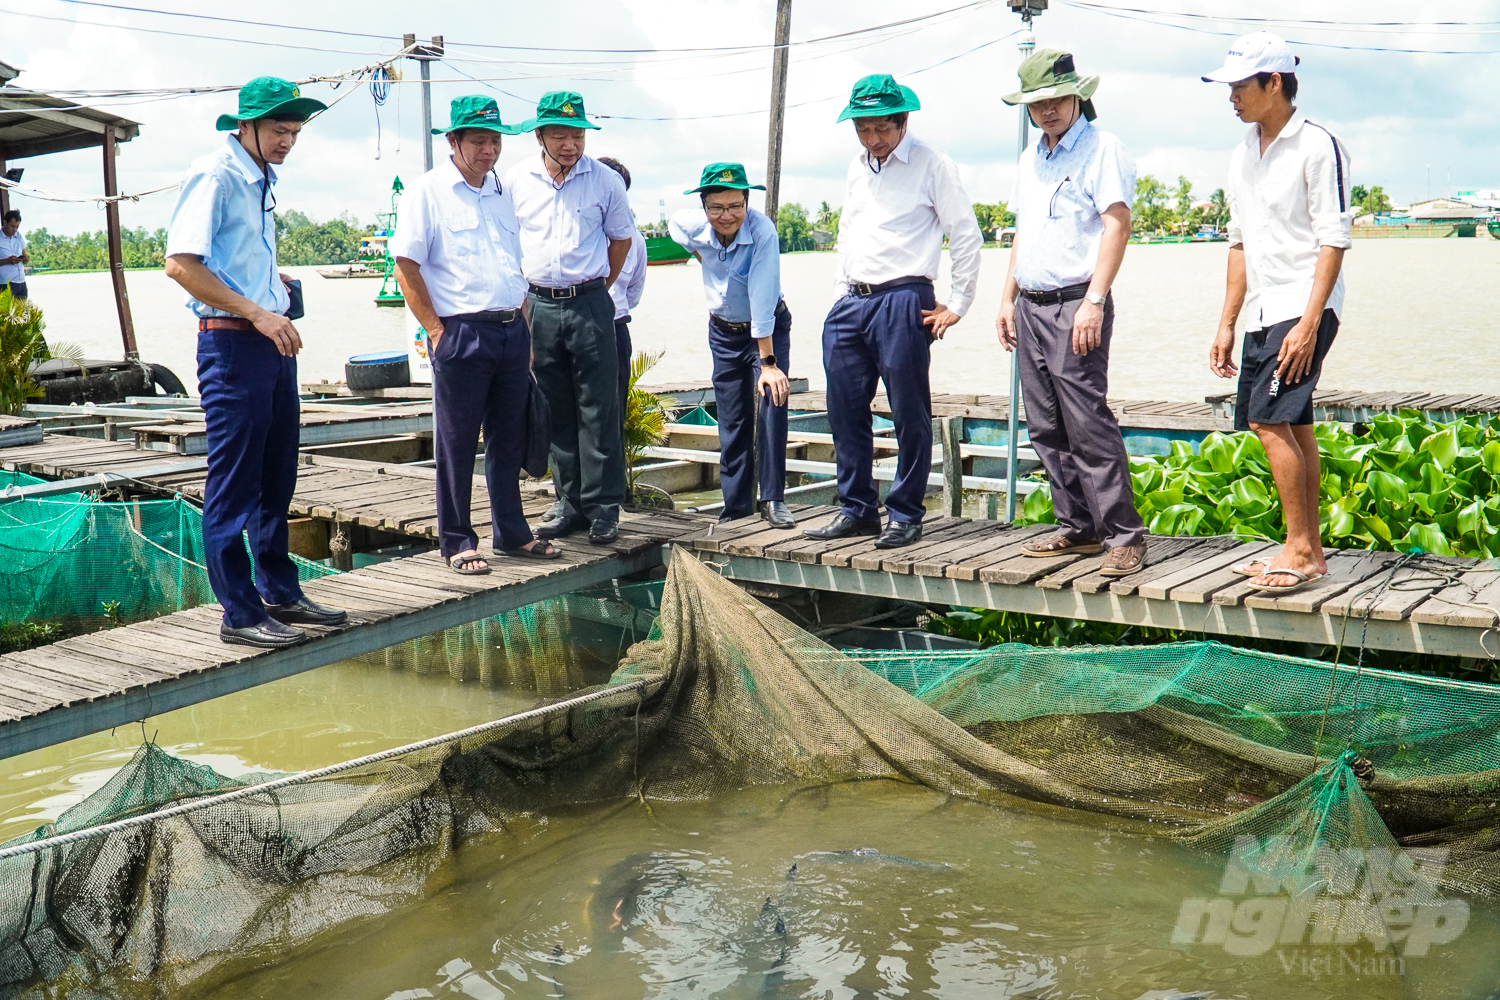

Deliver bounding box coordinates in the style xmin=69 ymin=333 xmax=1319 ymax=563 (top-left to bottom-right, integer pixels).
xmin=167 ymin=76 xmax=345 ymax=648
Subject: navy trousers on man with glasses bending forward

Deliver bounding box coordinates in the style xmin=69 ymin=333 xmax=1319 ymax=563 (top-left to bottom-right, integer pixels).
xmin=708 ymin=301 xmax=792 ymax=517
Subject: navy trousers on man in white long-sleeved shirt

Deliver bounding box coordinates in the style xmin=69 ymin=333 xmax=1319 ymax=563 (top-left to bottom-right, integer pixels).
xmin=824 ymin=283 xmax=936 ymax=525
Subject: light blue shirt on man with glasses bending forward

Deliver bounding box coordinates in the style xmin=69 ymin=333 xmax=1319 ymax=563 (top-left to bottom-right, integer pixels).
xmin=668 ymin=208 xmax=782 ymax=339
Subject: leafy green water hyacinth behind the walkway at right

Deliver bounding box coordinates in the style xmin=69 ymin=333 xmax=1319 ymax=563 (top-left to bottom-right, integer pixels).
xmin=1017 ymin=409 xmax=1500 ymax=558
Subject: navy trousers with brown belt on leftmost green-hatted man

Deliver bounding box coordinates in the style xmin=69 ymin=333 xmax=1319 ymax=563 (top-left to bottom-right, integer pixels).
xmin=198 ymin=330 xmax=302 ymax=628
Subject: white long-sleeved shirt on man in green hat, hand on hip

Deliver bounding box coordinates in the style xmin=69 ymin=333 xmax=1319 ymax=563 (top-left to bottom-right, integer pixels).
xmin=834 ymin=132 xmax=984 ymax=316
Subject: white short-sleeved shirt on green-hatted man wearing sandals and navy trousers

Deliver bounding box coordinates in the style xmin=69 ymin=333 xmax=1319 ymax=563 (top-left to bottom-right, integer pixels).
xmin=390 ymin=157 xmax=527 ymax=316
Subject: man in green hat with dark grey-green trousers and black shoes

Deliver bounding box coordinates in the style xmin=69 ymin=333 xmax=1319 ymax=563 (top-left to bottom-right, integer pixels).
xmin=506 ymin=90 xmax=636 ymax=546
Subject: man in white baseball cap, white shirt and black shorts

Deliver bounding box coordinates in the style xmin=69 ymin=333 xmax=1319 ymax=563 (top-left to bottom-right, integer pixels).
xmin=1203 ymin=31 xmax=1353 ymax=594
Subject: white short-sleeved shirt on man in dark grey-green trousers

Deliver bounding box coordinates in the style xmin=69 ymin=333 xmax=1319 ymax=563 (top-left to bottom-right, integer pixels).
xmin=506 ymin=151 xmax=636 ymax=288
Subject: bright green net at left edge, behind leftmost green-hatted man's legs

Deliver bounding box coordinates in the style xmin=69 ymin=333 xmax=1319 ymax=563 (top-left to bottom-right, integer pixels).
xmin=0 ymin=494 xmax=335 ymax=631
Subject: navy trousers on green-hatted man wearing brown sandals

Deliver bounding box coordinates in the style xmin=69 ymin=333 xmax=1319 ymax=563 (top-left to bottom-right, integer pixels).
xmin=432 ymin=315 xmax=533 ymax=559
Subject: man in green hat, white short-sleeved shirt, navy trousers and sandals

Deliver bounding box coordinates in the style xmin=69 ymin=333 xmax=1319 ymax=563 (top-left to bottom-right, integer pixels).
xmin=390 ymin=96 xmax=558 ymax=574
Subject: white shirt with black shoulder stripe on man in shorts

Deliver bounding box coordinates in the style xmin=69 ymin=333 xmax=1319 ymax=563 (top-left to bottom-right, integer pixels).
xmin=1229 ymin=112 xmax=1355 ymax=330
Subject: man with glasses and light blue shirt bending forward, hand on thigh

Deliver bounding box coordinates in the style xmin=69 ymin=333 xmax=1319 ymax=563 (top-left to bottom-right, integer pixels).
xmin=669 ymin=163 xmax=797 ymax=528
